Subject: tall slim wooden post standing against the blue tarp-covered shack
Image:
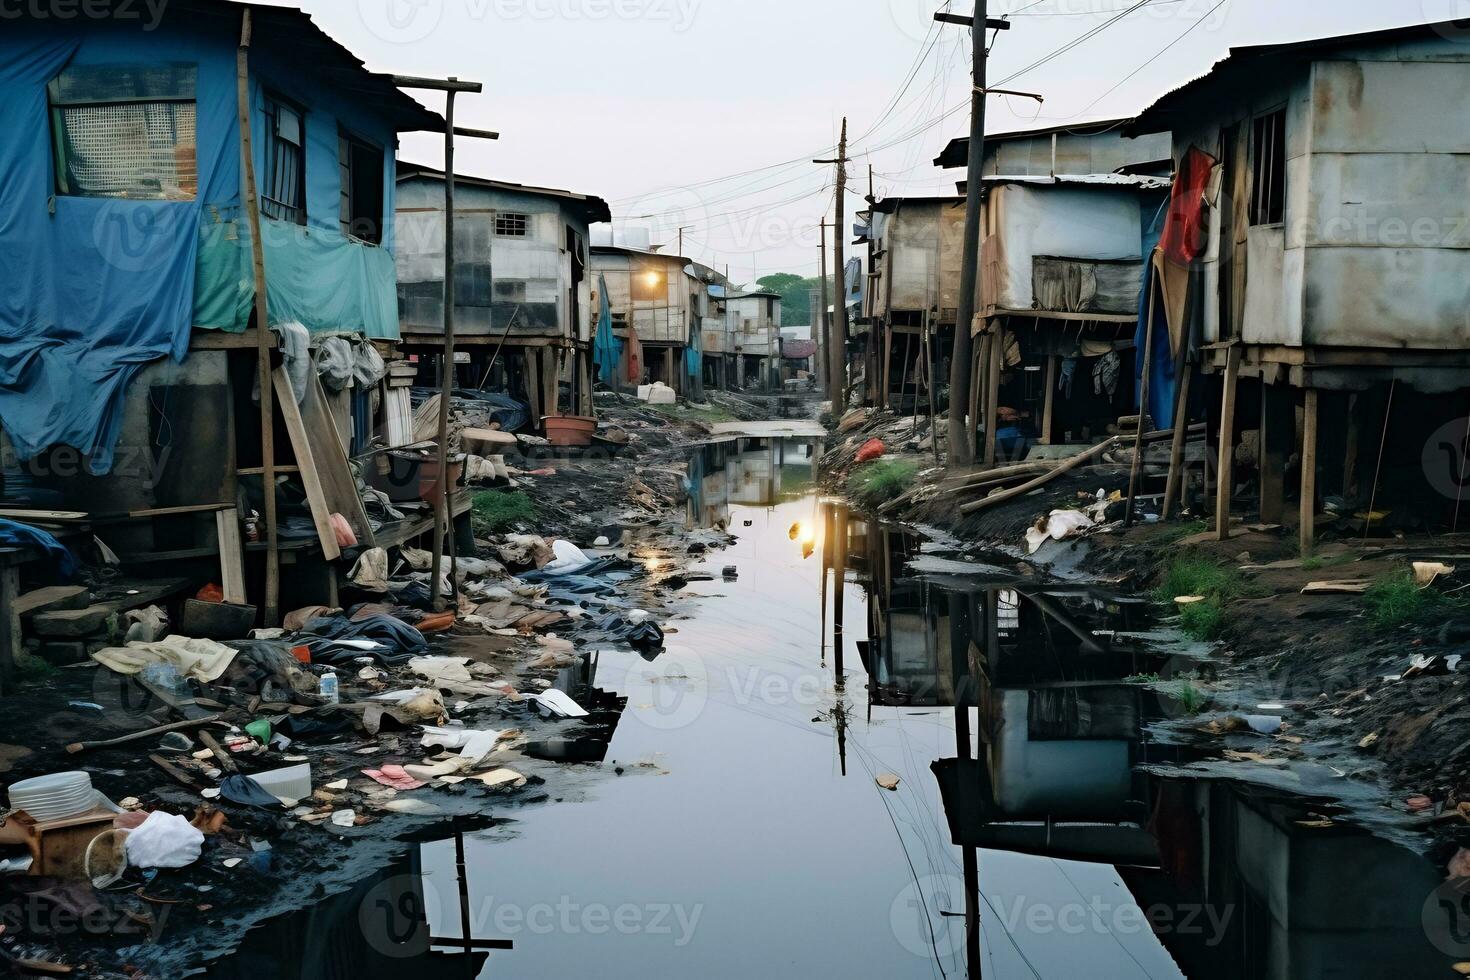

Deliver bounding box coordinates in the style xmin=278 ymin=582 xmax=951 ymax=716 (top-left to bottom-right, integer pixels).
xmin=235 ymin=7 xmax=281 ymax=626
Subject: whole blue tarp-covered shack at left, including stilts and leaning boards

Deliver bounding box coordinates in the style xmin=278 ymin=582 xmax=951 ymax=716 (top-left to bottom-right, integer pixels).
xmin=0 ymin=0 xmax=444 ymax=625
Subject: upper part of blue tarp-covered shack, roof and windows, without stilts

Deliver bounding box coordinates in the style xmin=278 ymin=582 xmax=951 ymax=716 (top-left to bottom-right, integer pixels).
xmin=0 ymin=0 xmax=444 ymax=472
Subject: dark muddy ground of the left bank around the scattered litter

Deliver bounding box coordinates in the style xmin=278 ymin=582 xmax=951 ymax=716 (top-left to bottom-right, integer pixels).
xmin=0 ymin=395 xmax=810 ymax=979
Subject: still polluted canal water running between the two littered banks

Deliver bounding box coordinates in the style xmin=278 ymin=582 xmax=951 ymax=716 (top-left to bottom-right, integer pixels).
xmin=210 ymin=438 xmax=1470 ymax=979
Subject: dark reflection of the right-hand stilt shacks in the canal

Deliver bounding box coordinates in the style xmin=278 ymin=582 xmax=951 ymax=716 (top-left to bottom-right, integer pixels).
xmin=829 ymin=508 xmax=1470 ymax=980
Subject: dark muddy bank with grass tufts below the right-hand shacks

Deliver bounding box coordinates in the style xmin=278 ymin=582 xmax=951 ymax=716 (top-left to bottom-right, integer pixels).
xmin=823 ymin=413 xmax=1470 ymax=851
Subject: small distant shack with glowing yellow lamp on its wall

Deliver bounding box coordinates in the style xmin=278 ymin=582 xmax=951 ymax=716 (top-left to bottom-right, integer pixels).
xmin=592 ymin=245 xmax=706 ymax=392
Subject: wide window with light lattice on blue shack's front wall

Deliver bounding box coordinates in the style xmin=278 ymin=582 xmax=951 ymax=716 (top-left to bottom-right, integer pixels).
xmin=47 ymin=63 xmax=198 ymax=201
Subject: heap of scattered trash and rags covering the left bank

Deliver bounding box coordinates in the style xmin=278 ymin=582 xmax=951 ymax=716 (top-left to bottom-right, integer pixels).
xmin=0 ymin=520 xmax=663 ymax=973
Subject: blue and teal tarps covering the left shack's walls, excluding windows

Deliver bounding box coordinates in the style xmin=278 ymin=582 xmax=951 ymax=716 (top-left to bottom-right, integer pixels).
xmin=0 ymin=19 xmax=397 ymax=473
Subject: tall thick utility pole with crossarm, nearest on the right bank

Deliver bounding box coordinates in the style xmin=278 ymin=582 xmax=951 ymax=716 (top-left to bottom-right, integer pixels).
xmin=933 ymin=0 xmax=1010 ymax=466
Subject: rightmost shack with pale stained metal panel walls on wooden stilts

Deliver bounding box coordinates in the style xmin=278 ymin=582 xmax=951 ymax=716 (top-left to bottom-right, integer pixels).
xmin=1129 ymin=24 xmax=1470 ymax=550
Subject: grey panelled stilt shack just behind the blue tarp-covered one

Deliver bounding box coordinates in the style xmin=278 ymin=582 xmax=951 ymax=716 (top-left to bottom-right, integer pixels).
xmin=397 ymin=163 xmax=612 ymax=420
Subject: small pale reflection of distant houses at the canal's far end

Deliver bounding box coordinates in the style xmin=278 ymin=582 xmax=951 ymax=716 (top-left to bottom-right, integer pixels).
xmin=688 ymin=439 xmax=820 ymax=527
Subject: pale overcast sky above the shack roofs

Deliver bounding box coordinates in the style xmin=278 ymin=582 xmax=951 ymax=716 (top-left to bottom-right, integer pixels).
xmin=291 ymin=0 xmax=1452 ymax=281
